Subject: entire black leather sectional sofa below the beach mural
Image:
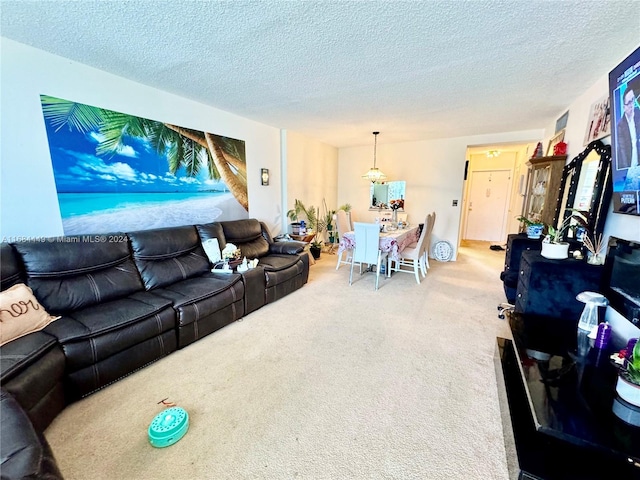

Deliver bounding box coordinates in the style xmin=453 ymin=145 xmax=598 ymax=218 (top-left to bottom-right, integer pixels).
xmin=0 ymin=219 xmax=309 ymax=479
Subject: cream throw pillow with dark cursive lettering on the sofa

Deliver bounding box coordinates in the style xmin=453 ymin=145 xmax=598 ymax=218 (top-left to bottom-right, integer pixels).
xmin=0 ymin=283 xmax=60 ymax=346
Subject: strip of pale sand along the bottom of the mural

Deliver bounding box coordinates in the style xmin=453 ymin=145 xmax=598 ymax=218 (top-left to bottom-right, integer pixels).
xmin=62 ymin=194 xmax=249 ymax=235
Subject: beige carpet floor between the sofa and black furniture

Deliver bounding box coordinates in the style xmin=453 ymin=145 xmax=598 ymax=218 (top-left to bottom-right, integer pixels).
xmin=46 ymin=242 xmax=512 ymax=480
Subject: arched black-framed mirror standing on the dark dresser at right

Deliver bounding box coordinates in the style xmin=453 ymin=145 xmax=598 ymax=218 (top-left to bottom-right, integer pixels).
xmin=553 ymin=140 xmax=612 ymax=240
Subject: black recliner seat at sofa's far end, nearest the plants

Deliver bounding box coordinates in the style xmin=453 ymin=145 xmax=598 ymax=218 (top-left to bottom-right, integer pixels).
xmin=196 ymin=219 xmax=309 ymax=309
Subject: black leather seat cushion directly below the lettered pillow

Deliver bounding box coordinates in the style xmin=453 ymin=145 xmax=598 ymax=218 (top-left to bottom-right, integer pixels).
xmin=0 ymin=332 xmax=58 ymax=384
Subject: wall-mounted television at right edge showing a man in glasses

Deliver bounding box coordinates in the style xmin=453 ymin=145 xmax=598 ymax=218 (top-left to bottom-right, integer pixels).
xmin=609 ymin=47 xmax=640 ymax=215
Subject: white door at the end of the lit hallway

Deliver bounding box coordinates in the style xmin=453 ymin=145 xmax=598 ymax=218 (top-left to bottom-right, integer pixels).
xmin=464 ymin=170 xmax=511 ymax=241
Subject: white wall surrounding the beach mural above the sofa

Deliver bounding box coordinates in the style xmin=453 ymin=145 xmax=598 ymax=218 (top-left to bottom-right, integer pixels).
xmin=0 ymin=38 xmax=282 ymax=237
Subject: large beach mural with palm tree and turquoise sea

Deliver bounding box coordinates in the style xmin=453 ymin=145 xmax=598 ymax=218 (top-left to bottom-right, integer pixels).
xmin=40 ymin=95 xmax=249 ymax=235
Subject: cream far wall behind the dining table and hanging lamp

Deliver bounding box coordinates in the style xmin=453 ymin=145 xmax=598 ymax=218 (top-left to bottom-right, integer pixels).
xmin=338 ymin=130 xmax=544 ymax=258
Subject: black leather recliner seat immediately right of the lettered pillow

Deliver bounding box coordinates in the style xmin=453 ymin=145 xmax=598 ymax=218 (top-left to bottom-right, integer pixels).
xmin=12 ymin=233 xmax=177 ymax=403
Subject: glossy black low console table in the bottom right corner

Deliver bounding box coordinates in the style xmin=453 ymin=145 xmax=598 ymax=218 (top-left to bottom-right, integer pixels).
xmin=496 ymin=313 xmax=640 ymax=480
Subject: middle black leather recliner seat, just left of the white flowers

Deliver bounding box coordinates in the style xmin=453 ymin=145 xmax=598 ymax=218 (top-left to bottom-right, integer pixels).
xmin=127 ymin=225 xmax=244 ymax=348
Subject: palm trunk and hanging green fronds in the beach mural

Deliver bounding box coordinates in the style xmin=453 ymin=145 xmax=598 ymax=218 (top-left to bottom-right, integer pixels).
xmin=41 ymin=95 xmax=249 ymax=211
